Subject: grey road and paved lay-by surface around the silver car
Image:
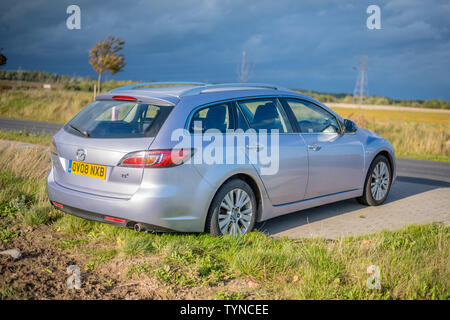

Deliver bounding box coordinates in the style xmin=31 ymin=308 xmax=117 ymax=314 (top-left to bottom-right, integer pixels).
xmin=0 ymin=118 xmax=450 ymax=239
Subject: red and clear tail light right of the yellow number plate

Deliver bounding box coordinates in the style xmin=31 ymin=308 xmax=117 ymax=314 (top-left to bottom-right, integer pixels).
xmin=118 ymin=149 xmax=193 ymax=168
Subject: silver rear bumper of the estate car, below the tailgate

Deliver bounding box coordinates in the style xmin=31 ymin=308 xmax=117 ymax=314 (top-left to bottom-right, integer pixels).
xmin=47 ymin=169 xmax=211 ymax=232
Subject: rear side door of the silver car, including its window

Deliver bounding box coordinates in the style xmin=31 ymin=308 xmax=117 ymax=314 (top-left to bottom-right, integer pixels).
xmin=237 ymin=98 xmax=308 ymax=205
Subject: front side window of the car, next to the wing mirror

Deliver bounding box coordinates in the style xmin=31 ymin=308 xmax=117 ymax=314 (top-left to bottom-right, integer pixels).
xmin=285 ymin=99 xmax=339 ymax=133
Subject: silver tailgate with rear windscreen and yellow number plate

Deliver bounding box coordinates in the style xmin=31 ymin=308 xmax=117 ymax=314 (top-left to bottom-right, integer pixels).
xmin=52 ymin=101 xmax=172 ymax=198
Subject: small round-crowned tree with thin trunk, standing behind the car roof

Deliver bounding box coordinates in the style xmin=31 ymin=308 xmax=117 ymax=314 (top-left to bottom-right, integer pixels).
xmin=89 ymin=36 xmax=126 ymax=92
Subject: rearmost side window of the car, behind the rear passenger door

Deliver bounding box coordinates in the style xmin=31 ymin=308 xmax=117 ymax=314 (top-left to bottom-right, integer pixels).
xmin=189 ymin=103 xmax=233 ymax=133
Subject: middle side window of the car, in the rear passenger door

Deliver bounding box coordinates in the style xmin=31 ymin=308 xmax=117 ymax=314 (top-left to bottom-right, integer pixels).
xmin=237 ymin=99 xmax=292 ymax=133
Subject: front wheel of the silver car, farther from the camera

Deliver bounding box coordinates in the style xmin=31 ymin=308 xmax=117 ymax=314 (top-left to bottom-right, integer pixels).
xmin=356 ymin=155 xmax=392 ymax=206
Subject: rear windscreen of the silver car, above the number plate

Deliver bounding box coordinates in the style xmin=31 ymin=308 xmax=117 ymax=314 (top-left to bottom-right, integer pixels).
xmin=64 ymin=101 xmax=173 ymax=138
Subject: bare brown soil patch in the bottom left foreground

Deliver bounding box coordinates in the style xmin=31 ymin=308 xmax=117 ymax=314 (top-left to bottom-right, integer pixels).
xmin=0 ymin=226 xmax=255 ymax=300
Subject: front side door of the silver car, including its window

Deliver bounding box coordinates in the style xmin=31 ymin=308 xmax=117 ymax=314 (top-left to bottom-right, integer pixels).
xmin=283 ymin=98 xmax=364 ymax=199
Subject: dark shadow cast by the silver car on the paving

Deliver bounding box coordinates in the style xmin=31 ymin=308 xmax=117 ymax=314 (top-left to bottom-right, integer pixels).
xmin=256 ymin=176 xmax=450 ymax=234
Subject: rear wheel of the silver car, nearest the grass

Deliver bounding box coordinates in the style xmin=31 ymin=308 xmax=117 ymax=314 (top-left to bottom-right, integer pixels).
xmin=205 ymin=179 xmax=256 ymax=236
